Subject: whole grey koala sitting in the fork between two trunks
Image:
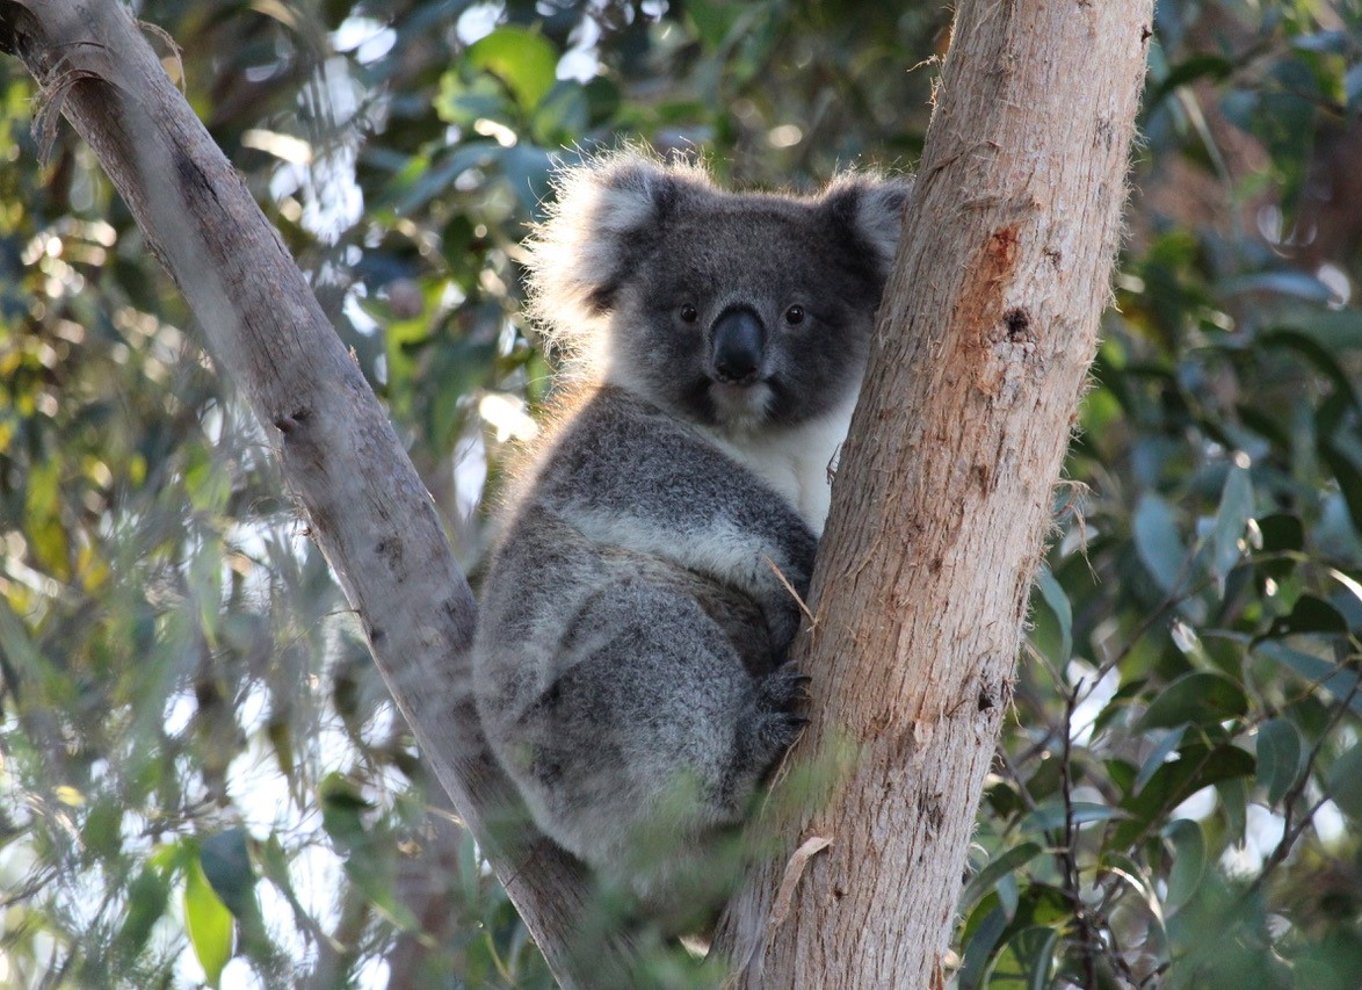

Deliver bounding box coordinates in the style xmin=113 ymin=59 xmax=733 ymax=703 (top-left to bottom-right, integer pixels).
xmin=474 ymin=150 xmax=911 ymax=910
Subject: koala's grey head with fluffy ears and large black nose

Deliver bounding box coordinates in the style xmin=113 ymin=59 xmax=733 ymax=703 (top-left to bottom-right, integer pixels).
xmin=527 ymin=151 xmax=911 ymax=429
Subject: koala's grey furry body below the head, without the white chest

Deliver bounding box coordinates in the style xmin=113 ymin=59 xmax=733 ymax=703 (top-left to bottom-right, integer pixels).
xmin=475 ymin=387 xmax=814 ymax=896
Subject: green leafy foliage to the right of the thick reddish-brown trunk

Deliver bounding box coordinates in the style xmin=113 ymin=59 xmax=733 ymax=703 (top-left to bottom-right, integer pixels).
xmin=980 ymin=4 xmax=1362 ymax=987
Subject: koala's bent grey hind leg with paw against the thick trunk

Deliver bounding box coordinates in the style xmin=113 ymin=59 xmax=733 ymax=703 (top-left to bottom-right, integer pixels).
xmin=515 ymin=579 xmax=804 ymax=888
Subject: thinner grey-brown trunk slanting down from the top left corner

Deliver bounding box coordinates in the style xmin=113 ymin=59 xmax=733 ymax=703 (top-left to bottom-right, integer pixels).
xmin=0 ymin=0 xmax=629 ymax=987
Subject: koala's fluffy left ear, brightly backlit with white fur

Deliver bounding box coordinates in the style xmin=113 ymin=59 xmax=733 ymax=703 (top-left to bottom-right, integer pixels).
xmin=524 ymin=148 xmax=712 ymax=355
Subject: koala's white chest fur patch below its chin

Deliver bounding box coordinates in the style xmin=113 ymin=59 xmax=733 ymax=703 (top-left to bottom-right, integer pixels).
xmin=704 ymin=392 xmax=857 ymax=535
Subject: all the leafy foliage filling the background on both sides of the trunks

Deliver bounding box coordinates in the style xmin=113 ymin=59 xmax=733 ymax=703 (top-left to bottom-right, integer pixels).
xmin=0 ymin=0 xmax=1362 ymax=990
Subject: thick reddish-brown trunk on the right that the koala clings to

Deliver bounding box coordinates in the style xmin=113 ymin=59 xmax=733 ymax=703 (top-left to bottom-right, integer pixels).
xmin=718 ymin=0 xmax=1152 ymax=990
